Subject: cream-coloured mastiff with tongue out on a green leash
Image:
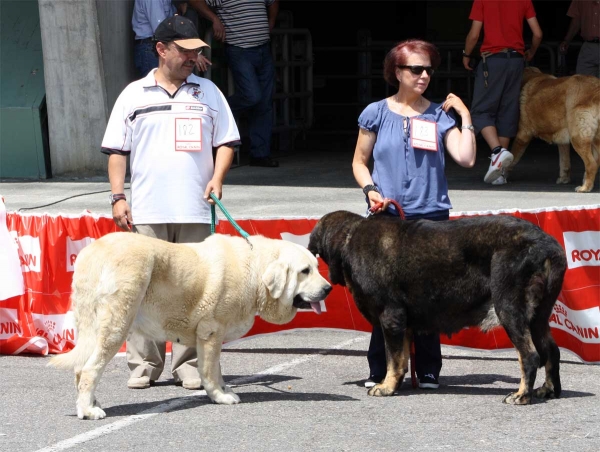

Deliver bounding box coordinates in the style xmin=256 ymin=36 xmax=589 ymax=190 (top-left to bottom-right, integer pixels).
xmin=49 ymin=232 xmax=331 ymax=419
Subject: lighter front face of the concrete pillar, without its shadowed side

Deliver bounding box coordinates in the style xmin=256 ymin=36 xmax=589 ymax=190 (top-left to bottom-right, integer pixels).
xmin=39 ymin=0 xmax=107 ymax=176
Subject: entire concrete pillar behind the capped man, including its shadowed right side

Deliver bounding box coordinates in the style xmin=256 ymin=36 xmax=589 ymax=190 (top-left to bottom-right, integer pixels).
xmin=39 ymin=0 xmax=133 ymax=177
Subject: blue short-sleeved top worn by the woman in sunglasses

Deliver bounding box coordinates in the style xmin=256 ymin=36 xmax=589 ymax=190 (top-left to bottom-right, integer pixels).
xmin=358 ymin=99 xmax=456 ymax=217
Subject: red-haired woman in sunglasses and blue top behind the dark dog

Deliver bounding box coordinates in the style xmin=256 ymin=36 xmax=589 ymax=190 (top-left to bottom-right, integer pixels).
xmin=352 ymin=40 xmax=476 ymax=389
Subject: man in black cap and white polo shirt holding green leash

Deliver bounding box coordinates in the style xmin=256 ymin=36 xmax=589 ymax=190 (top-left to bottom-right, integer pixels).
xmin=102 ymin=15 xmax=240 ymax=389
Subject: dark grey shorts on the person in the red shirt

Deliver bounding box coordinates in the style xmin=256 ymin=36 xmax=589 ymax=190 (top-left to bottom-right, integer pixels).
xmin=470 ymin=52 xmax=525 ymax=138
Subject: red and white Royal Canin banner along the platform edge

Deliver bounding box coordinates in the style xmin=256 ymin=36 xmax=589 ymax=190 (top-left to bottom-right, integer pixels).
xmin=0 ymin=203 xmax=600 ymax=363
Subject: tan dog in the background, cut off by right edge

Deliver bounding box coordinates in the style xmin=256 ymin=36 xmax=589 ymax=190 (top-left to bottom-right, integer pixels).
xmin=505 ymin=67 xmax=600 ymax=193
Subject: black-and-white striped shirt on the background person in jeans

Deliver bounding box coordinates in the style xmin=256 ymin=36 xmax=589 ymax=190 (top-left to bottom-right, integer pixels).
xmin=206 ymin=0 xmax=275 ymax=48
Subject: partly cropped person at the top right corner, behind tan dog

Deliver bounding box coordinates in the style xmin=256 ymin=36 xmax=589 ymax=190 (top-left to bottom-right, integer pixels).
xmin=559 ymin=0 xmax=600 ymax=77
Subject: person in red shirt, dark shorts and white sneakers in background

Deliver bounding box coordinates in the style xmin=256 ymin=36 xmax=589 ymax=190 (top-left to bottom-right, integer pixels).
xmin=463 ymin=0 xmax=542 ymax=184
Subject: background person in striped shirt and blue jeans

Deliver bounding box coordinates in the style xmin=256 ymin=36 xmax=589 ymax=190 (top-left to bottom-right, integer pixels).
xmin=189 ymin=0 xmax=279 ymax=168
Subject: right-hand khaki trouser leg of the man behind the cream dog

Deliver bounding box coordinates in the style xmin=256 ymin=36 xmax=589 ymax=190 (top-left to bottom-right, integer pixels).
xmin=169 ymin=223 xmax=210 ymax=389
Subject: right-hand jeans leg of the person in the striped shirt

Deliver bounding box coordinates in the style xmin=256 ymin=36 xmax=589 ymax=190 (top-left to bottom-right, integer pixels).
xmin=248 ymin=43 xmax=275 ymax=159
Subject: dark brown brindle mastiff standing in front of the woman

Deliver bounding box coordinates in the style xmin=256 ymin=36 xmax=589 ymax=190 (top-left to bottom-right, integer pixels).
xmin=308 ymin=211 xmax=567 ymax=405
